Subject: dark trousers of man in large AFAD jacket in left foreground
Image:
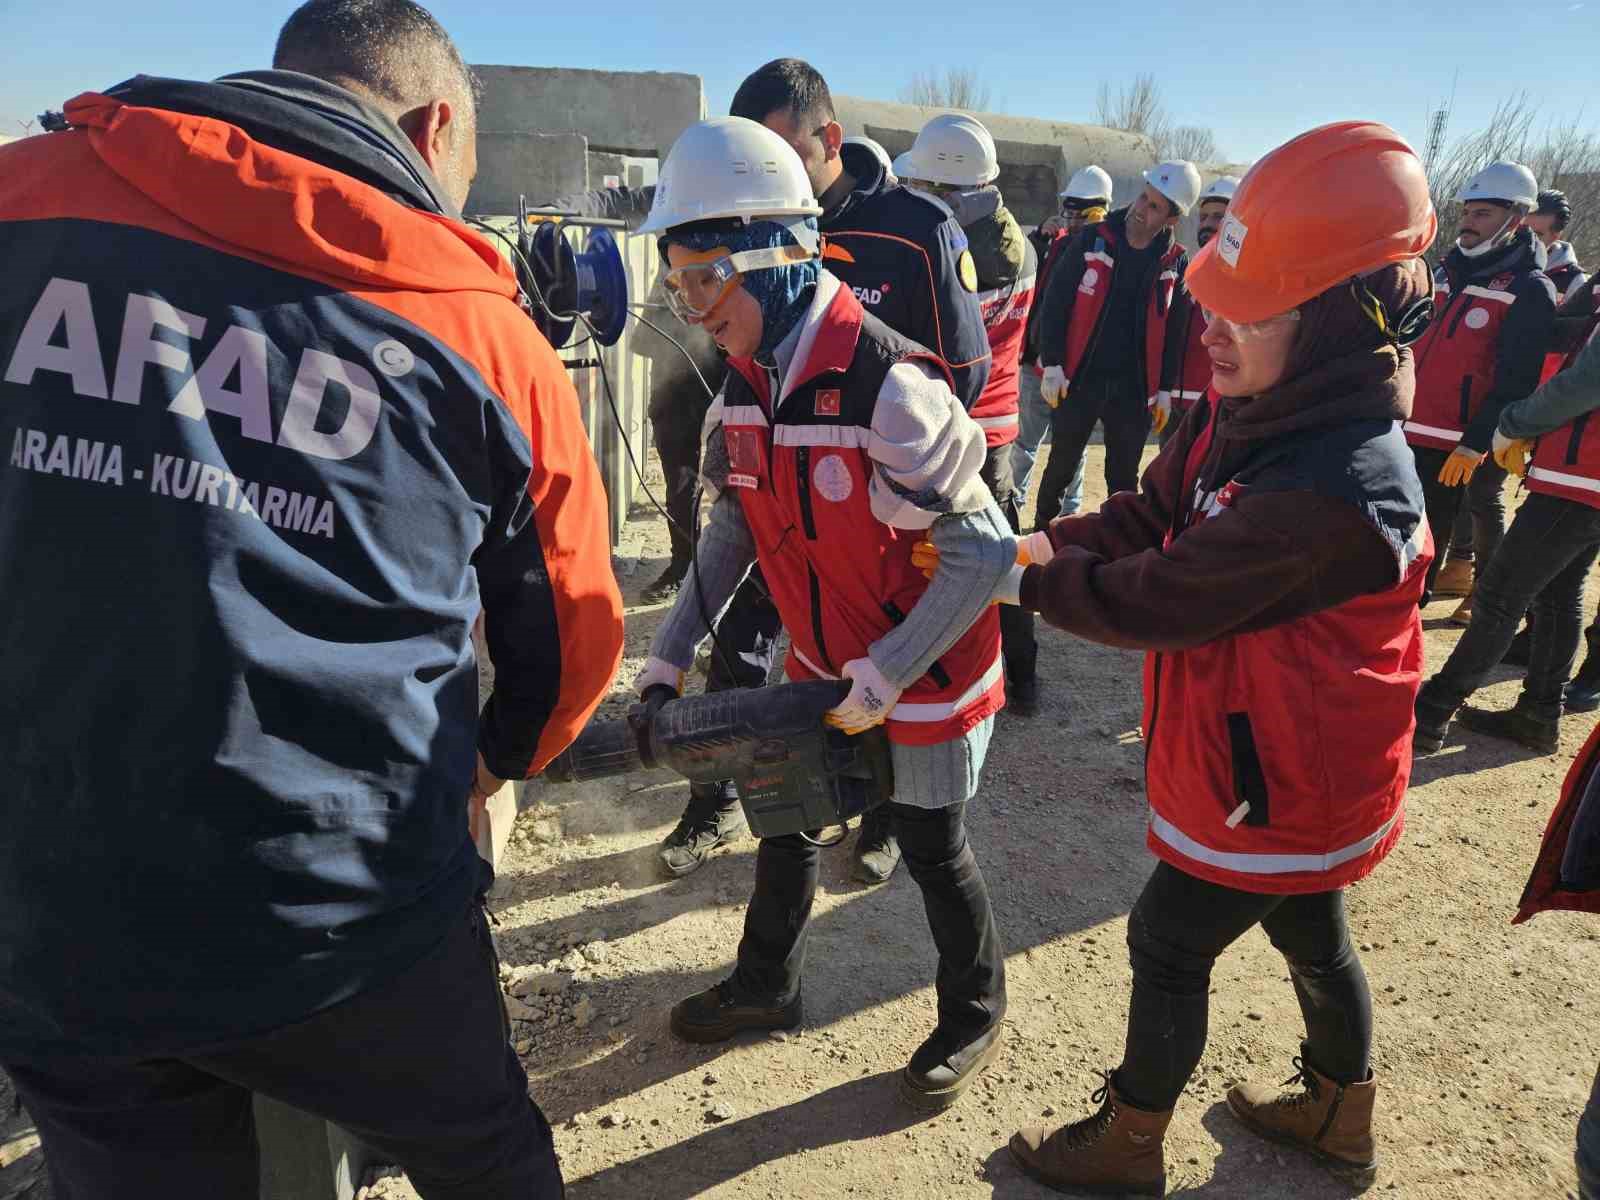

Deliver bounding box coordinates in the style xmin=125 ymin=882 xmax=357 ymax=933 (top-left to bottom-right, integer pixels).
xmin=5 ymin=904 xmax=563 ymax=1200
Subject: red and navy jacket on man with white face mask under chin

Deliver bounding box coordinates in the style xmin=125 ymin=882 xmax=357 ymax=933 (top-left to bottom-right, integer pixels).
xmin=1405 ymin=227 xmax=1555 ymax=454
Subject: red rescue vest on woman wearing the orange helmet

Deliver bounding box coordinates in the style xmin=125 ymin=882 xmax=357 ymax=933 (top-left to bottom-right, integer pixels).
xmin=1144 ymin=395 xmax=1434 ymax=893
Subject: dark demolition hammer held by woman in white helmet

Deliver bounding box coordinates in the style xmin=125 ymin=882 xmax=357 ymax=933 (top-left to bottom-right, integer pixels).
xmin=544 ymin=680 xmax=894 ymax=837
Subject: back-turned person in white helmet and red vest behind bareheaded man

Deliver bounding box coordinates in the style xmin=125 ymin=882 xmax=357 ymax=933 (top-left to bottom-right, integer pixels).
xmin=894 ymin=112 xmax=1038 ymax=717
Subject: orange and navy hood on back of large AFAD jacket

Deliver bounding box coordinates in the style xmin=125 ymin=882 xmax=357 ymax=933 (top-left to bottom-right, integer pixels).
xmin=56 ymin=72 xmax=517 ymax=299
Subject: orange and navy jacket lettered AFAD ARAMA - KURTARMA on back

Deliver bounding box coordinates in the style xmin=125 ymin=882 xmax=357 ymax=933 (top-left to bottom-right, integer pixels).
xmin=0 ymin=72 xmax=622 ymax=1056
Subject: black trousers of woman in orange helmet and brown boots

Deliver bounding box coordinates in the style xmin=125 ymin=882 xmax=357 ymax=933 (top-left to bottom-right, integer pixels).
xmin=1117 ymin=862 xmax=1373 ymax=1112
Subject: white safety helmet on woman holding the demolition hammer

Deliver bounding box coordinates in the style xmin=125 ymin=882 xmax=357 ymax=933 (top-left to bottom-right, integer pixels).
xmin=638 ymin=117 xmax=822 ymax=253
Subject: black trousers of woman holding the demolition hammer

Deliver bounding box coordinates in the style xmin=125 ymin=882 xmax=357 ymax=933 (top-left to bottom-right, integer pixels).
xmin=738 ymin=803 xmax=1005 ymax=1040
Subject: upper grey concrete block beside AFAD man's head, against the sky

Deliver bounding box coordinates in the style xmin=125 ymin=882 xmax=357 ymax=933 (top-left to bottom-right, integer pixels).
xmin=472 ymin=66 xmax=706 ymax=157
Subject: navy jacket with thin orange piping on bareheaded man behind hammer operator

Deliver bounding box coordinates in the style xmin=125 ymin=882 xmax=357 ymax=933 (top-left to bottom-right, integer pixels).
xmin=821 ymin=146 xmax=990 ymax=411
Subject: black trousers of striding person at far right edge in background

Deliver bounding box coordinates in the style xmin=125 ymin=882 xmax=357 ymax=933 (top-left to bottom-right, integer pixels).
xmin=1418 ymin=491 xmax=1600 ymax=720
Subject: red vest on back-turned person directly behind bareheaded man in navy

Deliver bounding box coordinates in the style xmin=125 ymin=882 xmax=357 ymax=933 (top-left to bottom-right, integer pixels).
xmin=966 ymin=205 xmax=1038 ymax=448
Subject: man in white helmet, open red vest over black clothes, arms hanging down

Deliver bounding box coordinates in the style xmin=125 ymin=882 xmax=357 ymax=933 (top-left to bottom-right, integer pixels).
xmin=1035 ymin=162 xmax=1200 ymax=528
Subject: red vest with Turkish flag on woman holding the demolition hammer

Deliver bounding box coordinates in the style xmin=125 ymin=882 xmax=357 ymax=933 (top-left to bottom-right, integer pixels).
xmin=722 ymin=274 xmax=1005 ymax=746
